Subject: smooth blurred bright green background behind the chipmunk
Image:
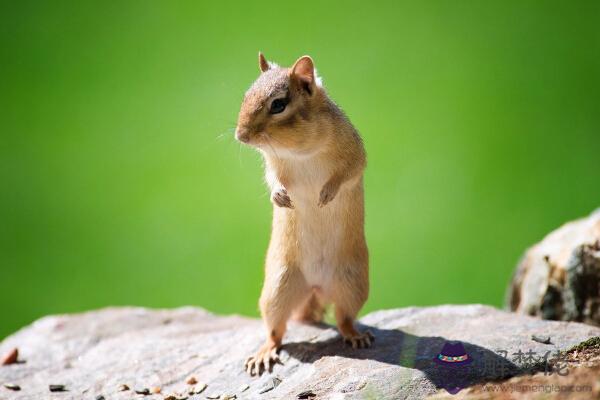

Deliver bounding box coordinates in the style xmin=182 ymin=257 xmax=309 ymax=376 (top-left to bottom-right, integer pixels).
xmin=0 ymin=1 xmax=600 ymax=337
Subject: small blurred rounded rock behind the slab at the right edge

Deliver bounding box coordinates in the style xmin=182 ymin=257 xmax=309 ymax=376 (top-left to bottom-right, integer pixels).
xmin=507 ymin=210 xmax=600 ymax=325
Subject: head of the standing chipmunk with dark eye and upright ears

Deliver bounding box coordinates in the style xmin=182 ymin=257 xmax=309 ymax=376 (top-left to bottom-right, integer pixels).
xmin=235 ymin=53 xmax=325 ymax=153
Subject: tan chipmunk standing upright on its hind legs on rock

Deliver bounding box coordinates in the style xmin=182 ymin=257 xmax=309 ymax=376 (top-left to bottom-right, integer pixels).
xmin=235 ymin=53 xmax=374 ymax=375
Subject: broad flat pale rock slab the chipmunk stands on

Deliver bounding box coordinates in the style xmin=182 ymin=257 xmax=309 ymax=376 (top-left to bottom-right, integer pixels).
xmin=0 ymin=305 xmax=600 ymax=400
